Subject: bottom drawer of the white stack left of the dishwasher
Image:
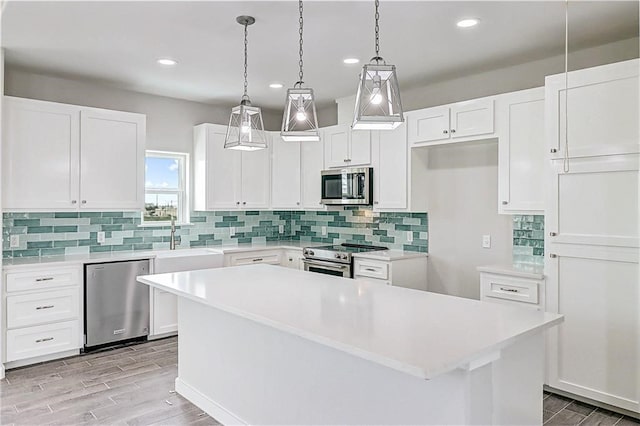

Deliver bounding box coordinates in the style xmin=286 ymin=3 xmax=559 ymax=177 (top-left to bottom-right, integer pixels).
xmin=7 ymin=320 xmax=80 ymax=362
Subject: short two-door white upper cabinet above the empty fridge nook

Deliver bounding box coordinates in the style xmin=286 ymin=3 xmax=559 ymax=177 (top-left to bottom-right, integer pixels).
xmin=406 ymin=98 xmax=495 ymax=146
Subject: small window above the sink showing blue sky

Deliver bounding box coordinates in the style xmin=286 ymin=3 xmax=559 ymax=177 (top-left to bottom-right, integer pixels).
xmin=142 ymin=151 xmax=189 ymax=224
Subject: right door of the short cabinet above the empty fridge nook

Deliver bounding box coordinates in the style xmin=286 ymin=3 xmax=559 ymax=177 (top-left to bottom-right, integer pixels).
xmin=450 ymin=99 xmax=494 ymax=138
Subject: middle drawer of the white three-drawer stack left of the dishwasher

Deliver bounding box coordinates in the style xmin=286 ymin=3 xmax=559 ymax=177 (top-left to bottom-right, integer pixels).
xmin=7 ymin=288 xmax=80 ymax=328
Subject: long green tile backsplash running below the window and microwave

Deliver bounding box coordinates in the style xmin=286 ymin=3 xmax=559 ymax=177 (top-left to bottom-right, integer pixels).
xmin=2 ymin=208 xmax=428 ymax=259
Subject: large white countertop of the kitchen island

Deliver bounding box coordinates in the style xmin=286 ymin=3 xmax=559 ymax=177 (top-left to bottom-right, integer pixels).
xmin=138 ymin=265 xmax=562 ymax=379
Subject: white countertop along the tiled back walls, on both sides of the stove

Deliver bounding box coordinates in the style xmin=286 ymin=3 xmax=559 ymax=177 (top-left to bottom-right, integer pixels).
xmin=2 ymin=241 xmax=427 ymax=270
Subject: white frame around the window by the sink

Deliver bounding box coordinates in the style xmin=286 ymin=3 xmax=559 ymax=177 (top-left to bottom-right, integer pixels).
xmin=140 ymin=149 xmax=190 ymax=227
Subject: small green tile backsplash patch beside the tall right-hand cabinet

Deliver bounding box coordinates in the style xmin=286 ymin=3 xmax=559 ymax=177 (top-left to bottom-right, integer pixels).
xmin=513 ymin=215 xmax=544 ymax=265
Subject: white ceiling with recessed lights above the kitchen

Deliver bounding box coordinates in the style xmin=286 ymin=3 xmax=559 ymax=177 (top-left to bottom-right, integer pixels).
xmin=2 ymin=0 xmax=638 ymax=108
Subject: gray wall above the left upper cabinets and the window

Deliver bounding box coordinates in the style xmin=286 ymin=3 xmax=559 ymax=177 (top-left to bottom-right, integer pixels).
xmin=5 ymin=66 xmax=282 ymax=153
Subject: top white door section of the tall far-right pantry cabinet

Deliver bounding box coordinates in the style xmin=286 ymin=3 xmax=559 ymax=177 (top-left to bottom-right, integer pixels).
xmin=545 ymin=59 xmax=640 ymax=159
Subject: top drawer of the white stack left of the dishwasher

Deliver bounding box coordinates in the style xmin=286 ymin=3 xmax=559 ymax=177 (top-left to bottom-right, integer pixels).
xmin=6 ymin=267 xmax=81 ymax=293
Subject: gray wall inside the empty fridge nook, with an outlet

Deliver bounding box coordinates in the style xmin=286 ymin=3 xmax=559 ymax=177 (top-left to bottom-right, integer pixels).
xmin=420 ymin=140 xmax=512 ymax=298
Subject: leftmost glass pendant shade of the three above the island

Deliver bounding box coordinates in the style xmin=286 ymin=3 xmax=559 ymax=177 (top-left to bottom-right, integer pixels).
xmin=224 ymin=99 xmax=267 ymax=151
